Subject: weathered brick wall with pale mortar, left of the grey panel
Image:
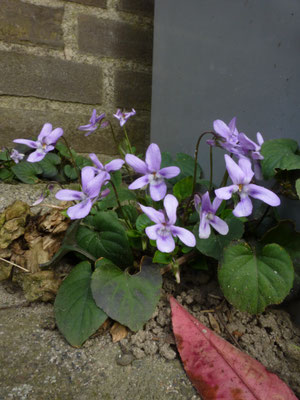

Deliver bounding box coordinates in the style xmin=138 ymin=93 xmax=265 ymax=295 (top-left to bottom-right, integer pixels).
xmin=0 ymin=0 xmax=154 ymax=159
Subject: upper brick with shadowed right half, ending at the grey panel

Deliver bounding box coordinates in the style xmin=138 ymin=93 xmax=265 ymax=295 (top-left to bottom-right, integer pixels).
xmin=78 ymin=14 xmax=153 ymax=64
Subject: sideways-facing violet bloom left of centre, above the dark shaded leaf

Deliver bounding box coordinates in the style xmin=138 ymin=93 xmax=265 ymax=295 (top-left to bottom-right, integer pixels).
xmin=55 ymin=167 xmax=109 ymax=219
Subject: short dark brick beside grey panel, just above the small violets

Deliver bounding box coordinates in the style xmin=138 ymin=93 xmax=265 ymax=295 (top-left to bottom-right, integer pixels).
xmin=115 ymin=71 xmax=152 ymax=109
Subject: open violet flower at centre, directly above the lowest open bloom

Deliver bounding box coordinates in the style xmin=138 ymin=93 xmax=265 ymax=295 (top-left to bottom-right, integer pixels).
xmin=125 ymin=143 xmax=180 ymax=201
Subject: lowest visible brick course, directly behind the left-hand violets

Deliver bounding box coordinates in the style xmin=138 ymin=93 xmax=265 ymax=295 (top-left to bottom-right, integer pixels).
xmin=0 ymin=108 xmax=150 ymax=155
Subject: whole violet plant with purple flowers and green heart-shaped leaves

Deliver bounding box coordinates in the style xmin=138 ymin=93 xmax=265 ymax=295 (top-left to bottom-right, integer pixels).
xmin=0 ymin=109 xmax=300 ymax=346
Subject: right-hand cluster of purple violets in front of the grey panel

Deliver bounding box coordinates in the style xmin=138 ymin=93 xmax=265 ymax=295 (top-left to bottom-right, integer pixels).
xmin=194 ymin=118 xmax=280 ymax=239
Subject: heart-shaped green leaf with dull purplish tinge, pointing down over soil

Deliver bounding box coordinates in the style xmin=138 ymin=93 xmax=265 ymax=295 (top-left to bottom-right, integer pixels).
xmin=91 ymin=259 xmax=162 ymax=331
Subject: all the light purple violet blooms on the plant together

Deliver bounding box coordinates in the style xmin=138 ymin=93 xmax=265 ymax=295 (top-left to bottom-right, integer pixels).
xmin=10 ymin=109 xmax=280 ymax=253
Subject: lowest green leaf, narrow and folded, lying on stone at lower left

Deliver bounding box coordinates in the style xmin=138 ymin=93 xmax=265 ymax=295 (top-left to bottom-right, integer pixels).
xmin=54 ymin=261 xmax=107 ymax=347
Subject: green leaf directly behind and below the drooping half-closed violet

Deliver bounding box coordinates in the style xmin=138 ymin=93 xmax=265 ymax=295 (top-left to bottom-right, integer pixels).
xmin=193 ymin=213 xmax=244 ymax=260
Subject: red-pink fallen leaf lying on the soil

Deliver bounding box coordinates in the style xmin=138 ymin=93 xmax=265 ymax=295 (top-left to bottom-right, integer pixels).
xmin=170 ymin=297 xmax=297 ymax=400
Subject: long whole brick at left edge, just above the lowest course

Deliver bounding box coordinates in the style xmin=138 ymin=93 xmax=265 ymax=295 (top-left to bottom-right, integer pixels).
xmin=0 ymin=51 xmax=102 ymax=104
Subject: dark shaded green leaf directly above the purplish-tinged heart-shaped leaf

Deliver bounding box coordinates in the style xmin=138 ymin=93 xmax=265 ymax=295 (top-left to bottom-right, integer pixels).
xmin=76 ymin=211 xmax=133 ymax=267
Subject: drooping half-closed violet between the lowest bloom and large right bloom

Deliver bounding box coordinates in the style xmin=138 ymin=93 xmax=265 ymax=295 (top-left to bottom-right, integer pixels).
xmin=194 ymin=192 xmax=229 ymax=239
